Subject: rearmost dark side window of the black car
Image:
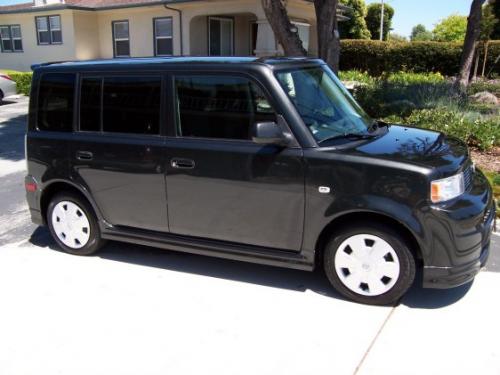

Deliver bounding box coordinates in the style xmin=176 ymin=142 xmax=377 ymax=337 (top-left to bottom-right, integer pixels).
xmin=37 ymin=73 xmax=76 ymax=132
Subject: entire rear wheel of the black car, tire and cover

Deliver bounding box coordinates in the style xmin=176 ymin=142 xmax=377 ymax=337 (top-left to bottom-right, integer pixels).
xmin=47 ymin=192 xmax=104 ymax=255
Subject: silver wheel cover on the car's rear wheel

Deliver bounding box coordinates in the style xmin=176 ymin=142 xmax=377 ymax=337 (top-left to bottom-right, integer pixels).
xmin=51 ymin=201 xmax=90 ymax=249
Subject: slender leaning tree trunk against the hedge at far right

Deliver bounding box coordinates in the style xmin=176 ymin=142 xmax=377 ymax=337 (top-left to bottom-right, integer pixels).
xmin=455 ymin=0 xmax=485 ymax=91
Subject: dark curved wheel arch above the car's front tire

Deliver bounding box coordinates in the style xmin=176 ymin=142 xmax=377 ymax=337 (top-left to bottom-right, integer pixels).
xmin=315 ymin=211 xmax=423 ymax=264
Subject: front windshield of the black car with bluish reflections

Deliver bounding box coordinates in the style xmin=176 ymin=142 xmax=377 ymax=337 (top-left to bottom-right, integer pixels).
xmin=276 ymin=65 xmax=373 ymax=143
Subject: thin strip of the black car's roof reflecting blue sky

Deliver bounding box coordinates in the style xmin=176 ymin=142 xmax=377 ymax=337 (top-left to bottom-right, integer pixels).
xmin=31 ymin=56 xmax=324 ymax=71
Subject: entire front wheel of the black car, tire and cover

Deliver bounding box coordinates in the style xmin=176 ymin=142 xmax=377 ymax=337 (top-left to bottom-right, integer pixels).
xmin=324 ymin=224 xmax=415 ymax=305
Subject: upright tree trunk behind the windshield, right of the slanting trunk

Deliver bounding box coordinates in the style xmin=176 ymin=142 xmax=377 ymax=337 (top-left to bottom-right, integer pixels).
xmin=314 ymin=0 xmax=340 ymax=73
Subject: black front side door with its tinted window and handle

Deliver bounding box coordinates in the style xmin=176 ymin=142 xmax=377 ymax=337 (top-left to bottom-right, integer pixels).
xmin=166 ymin=75 xmax=304 ymax=251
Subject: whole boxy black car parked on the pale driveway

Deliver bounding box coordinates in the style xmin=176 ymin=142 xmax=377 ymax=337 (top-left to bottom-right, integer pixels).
xmin=26 ymin=57 xmax=495 ymax=304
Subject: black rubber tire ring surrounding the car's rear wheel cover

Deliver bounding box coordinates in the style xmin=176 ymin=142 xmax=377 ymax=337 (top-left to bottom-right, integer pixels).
xmin=46 ymin=192 xmax=106 ymax=255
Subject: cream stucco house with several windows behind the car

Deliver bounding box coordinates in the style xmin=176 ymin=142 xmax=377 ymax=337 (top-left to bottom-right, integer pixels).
xmin=0 ymin=0 xmax=350 ymax=71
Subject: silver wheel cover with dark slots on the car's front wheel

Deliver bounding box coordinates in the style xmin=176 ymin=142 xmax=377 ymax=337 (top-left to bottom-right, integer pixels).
xmin=335 ymin=234 xmax=401 ymax=296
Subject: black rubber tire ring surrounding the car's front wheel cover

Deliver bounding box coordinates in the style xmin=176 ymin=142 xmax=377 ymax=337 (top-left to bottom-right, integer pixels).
xmin=323 ymin=223 xmax=416 ymax=305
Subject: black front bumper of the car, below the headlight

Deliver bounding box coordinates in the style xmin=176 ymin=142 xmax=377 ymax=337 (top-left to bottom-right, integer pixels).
xmin=423 ymin=172 xmax=496 ymax=289
